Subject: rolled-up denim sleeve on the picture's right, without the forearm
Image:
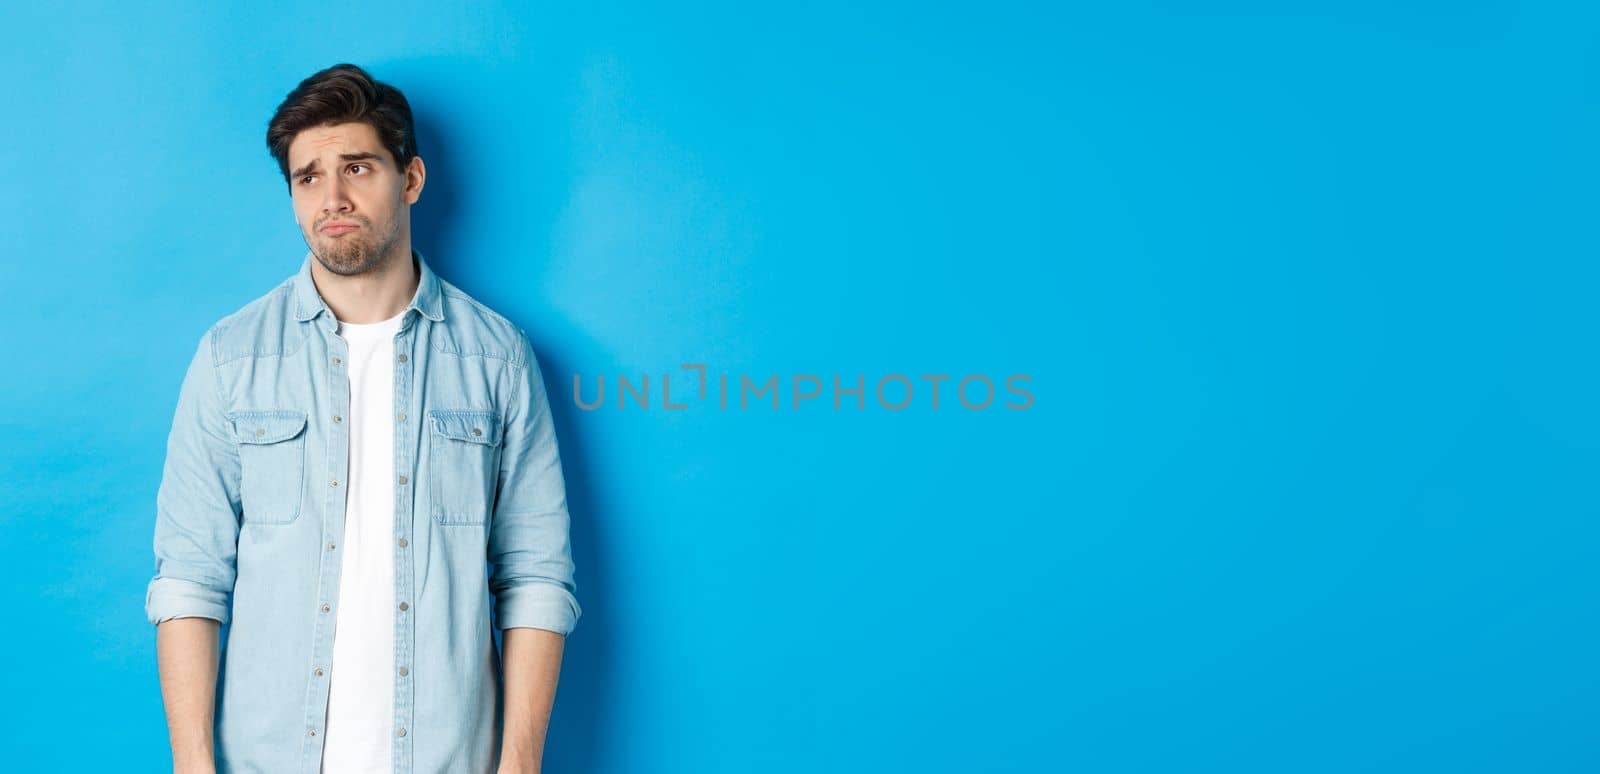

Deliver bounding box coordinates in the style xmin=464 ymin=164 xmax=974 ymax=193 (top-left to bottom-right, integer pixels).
xmin=488 ymin=329 xmax=582 ymax=635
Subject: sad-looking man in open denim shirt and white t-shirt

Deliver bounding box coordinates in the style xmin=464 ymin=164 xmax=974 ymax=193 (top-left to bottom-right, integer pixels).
xmin=146 ymin=64 xmax=581 ymax=774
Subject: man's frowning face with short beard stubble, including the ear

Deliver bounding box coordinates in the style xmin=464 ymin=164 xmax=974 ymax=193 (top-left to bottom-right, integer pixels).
xmin=290 ymin=123 xmax=422 ymax=275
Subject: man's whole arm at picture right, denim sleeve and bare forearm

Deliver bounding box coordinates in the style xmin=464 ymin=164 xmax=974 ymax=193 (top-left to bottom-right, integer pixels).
xmin=488 ymin=331 xmax=582 ymax=772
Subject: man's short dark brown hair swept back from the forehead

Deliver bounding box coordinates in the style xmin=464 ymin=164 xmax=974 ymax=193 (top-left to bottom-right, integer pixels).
xmin=267 ymin=64 xmax=416 ymax=186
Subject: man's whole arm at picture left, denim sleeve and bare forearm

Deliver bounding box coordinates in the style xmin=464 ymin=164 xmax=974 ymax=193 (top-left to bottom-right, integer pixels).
xmin=144 ymin=331 xmax=238 ymax=771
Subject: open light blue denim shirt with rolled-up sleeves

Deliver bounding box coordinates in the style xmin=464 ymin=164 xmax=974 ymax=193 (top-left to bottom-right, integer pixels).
xmin=146 ymin=251 xmax=581 ymax=774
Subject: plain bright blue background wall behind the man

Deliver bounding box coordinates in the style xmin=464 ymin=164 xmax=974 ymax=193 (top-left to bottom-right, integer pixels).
xmin=0 ymin=2 xmax=1600 ymax=774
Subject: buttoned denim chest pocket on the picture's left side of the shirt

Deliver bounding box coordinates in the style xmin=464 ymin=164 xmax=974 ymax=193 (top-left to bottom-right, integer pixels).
xmin=230 ymin=409 xmax=306 ymax=525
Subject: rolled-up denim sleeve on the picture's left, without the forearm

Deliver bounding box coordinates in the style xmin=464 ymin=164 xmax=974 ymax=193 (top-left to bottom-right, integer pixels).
xmin=144 ymin=329 xmax=238 ymax=624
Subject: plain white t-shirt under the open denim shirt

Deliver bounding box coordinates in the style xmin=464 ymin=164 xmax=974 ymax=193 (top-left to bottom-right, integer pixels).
xmin=322 ymin=312 xmax=405 ymax=774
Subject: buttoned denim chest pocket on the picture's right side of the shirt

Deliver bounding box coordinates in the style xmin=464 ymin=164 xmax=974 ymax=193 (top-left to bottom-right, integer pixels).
xmin=427 ymin=409 xmax=501 ymax=525
